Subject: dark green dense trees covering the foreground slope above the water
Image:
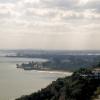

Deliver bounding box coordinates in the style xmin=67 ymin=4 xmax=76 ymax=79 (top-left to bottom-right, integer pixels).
xmin=16 ymin=69 xmax=100 ymax=100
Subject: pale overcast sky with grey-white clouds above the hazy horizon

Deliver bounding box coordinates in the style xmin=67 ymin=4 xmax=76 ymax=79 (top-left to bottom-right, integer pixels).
xmin=0 ymin=0 xmax=100 ymax=50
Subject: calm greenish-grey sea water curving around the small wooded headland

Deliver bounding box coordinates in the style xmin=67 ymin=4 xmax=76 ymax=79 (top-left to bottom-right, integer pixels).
xmin=0 ymin=56 xmax=71 ymax=100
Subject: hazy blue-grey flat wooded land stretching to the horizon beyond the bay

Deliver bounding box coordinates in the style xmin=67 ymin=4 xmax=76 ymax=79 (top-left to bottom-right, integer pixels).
xmin=3 ymin=50 xmax=100 ymax=71
